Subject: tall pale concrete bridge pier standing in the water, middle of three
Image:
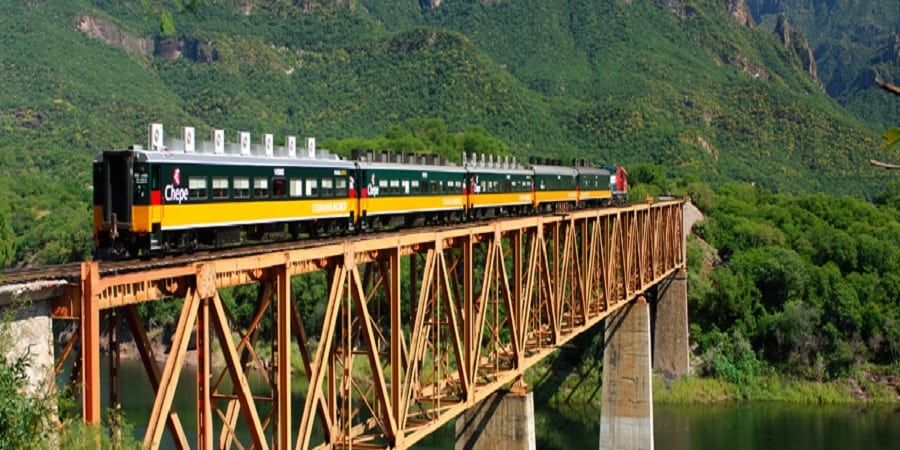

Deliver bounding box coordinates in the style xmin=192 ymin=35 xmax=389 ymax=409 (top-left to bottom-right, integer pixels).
xmin=600 ymin=297 xmax=653 ymax=450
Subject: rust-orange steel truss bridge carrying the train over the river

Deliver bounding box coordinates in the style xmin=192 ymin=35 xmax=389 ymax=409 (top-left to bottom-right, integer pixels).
xmin=47 ymin=200 xmax=685 ymax=449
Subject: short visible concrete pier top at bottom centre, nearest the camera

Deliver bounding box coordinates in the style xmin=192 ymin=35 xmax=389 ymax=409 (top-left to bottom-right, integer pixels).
xmin=455 ymin=391 xmax=537 ymax=450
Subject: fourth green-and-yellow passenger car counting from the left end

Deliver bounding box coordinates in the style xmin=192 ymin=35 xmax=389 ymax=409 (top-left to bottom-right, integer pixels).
xmin=530 ymin=159 xmax=578 ymax=212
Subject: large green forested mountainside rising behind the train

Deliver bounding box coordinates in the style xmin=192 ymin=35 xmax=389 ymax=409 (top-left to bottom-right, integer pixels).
xmin=0 ymin=0 xmax=900 ymax=261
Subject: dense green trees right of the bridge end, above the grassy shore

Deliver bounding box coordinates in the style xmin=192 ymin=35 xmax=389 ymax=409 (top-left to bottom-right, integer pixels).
xmin=688 ymin=183 xmax=900 ymax=381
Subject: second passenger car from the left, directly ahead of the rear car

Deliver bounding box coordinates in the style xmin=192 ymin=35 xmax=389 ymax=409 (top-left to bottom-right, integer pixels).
xmin=354 ymin=152 xmax=466 ymax=228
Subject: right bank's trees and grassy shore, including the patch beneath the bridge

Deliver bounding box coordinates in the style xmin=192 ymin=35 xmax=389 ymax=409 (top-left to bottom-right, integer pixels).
xmin=530 ymin=172 xmax=900 ymax=403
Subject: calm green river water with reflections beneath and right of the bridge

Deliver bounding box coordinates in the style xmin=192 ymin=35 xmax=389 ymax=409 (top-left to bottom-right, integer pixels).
xmin=110 ymin=360 xmax=900 ymax=450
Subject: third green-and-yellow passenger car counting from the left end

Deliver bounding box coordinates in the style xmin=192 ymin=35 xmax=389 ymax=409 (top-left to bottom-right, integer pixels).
xmin=462 ymin=153 xmax=534 ymax=218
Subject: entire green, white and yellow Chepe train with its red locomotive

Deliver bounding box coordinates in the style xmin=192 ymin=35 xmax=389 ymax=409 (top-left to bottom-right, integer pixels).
xmin=93 ymin=124 xmax=627 ymax=260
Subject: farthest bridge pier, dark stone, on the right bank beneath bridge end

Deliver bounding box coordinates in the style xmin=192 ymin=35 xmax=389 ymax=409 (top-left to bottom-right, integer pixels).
xmin=653 ymin=269 xmax=691 ymax=379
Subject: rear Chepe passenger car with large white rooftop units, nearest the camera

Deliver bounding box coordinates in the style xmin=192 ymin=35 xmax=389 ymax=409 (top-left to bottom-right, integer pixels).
xmin=94 ymin=124 xmax=358 ymax=259
